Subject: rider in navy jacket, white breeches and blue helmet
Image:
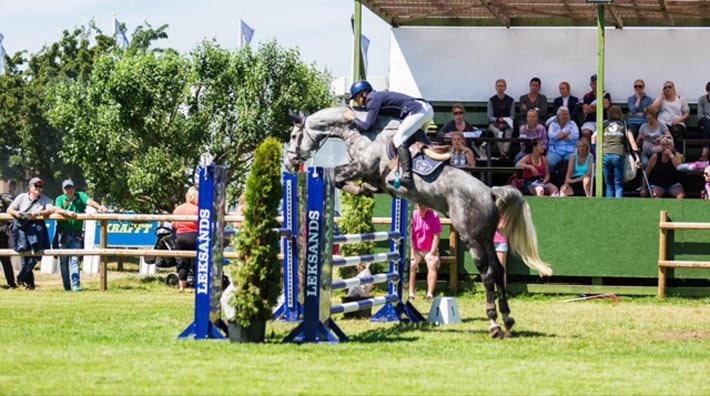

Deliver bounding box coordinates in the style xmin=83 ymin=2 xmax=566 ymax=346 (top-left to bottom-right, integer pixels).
xmin=345 ymin=80 xmax=434 ymax=187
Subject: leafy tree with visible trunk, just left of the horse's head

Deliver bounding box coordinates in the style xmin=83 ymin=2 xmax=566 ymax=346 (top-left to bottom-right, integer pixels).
xmin=188 ymin=41 xmax=334 ymax=203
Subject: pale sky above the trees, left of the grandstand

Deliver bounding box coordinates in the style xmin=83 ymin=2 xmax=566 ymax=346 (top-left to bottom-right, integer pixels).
xmin=0 ymin=0 xmax=390 ymax=77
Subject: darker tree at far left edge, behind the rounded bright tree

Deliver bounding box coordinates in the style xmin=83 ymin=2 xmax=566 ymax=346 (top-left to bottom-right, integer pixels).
xmin=0 ymin=22 xmax=115 ymax=191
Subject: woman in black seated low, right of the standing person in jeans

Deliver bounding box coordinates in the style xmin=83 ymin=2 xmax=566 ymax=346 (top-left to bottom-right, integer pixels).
xmin=646 ymin=137 xmax=685 ymax=199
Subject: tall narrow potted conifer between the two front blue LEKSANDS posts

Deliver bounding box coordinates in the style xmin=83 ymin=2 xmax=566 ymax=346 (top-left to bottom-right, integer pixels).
xmin=229 ymin=137 xmax=283 ymax=342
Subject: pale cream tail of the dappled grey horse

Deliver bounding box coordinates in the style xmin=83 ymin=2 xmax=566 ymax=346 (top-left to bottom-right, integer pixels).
xmin=492 ymin=186 xmax=552 ymax=276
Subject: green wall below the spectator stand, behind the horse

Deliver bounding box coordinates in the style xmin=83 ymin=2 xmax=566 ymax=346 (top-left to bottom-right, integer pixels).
xmin=375 ymin=195 xmax=710 ymax=278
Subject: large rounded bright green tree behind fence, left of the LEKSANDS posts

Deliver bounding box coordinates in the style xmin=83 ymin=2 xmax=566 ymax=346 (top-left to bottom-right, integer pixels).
xmin=51 ymin=50 xmax=197 ymax=212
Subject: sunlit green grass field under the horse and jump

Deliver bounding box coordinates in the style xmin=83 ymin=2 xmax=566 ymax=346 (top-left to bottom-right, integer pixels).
xmin=0 ymin=273 xmax=710 ymax=395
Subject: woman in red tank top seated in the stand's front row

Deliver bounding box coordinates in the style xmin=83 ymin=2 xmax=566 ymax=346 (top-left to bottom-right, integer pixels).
xmin=517 ymin=139 xmax=559 ymax=197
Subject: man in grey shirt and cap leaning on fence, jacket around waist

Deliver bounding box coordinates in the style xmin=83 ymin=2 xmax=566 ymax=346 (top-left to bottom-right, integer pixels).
xmin=7 ymin=177 xmax=76 ymax=290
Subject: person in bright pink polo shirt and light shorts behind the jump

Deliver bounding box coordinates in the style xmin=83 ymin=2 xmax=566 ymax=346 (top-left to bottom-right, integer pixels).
xmin=409 ymin=204 xmax=441 ymax=300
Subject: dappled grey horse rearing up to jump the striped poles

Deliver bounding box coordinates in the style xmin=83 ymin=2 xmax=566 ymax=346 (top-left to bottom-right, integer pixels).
xmin=286 ymin=107 xmax=552 ymax=337
